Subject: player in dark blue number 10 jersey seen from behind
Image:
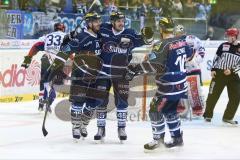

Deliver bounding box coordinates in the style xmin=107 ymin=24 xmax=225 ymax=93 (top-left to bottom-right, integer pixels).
xmin=126 ymin=17 xmax=192 ymax=150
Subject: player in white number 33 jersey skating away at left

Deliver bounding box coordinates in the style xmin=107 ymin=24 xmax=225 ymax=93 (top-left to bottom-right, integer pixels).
xmin=21 ymin=23 xmax=66 ymax=111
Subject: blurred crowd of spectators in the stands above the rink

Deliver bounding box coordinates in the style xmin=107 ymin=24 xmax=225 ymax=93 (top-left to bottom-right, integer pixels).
xmin=1 ymin=0 xmax=240 ymax=39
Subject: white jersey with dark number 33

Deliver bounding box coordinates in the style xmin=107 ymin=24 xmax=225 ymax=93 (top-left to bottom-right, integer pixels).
xmin=39 ymin=31 xmax=66 ymax=61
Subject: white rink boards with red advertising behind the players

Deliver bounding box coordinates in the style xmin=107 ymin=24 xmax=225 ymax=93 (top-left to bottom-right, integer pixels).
xmin=0 ymin=40 xmax=221 ymax=103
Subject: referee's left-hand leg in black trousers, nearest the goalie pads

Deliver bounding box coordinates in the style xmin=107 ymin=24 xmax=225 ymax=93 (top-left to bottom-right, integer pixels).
xmin=203 ymin=71 xmax=226 ymax=122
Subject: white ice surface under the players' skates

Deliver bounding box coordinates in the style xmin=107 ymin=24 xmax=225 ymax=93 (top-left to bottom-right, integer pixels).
xmin=0 ymin=87 xmax=240 ymax=160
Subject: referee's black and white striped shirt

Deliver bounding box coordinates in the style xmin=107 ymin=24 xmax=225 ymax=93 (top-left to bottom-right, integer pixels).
xmin=212 ymin=42 xmax=240 ymax=70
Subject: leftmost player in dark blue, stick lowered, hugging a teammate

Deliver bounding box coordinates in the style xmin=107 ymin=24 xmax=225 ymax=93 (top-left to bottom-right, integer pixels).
xmin=48 ymin=12 xmax=101 ymax=139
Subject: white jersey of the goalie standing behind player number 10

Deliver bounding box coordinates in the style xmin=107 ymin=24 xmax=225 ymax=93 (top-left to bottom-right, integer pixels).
xmin=186 ymin=35 xmax=205 ymax=72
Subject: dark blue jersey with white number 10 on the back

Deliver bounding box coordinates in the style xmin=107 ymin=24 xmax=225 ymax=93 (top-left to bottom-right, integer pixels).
xmin=149 ymin=37 xmax=192 ymax=100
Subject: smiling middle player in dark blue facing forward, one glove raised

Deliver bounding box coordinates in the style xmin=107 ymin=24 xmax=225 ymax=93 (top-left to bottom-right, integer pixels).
xmin=94 ymin=12 xmax=153 ymax=140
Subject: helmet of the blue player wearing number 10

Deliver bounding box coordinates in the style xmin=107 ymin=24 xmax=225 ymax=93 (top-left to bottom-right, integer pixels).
xmin=159 ymin=17 xmax=174 ymax=32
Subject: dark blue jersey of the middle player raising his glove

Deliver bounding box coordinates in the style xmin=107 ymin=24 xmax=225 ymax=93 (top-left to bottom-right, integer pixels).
xmin=100 ymin=23 xmax=145 ymax=75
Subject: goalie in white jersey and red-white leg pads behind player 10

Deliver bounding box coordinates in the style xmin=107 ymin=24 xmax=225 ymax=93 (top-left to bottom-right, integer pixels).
xmin=175 ymin=24 xmax=205 ymax=117
